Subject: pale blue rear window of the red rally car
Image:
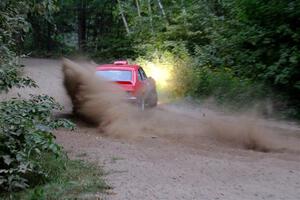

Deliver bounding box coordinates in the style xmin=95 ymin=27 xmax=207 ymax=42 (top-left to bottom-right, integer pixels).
xmin=96 ymin=70 xmax=132 ymax=81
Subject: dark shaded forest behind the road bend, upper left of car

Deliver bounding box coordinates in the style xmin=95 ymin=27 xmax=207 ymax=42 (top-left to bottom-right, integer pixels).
xmin=22 ymin=0 xmax=134 ymax=60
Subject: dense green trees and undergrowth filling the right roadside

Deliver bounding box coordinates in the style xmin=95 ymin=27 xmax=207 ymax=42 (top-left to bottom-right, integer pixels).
xmin=123 ymin=0 xmax=300 ymax=117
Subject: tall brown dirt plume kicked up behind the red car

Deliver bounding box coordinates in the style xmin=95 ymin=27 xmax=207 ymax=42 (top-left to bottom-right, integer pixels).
xmin=62 ymin=59 xmax=145 ymax=137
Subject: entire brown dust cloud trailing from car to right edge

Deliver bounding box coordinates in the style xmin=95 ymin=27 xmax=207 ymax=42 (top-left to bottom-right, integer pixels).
xmin=63 ymin=59 xmax=300 ymax=152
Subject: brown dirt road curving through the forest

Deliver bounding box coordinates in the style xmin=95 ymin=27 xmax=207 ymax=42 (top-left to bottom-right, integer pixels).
xmin=8 ymin=59 xmax=300 ymax=200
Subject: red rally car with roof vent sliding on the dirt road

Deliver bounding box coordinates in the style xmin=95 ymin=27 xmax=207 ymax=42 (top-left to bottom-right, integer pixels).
xmin=96 ymin=61 xmax=157 ymax=110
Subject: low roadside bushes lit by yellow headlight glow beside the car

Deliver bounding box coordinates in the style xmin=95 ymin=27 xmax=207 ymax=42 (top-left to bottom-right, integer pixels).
xmin=136 ymin=47 xmax=273 ymax=109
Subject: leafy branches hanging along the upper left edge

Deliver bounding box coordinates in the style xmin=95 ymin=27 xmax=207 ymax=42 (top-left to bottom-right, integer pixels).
xmin=0 ymin=0 xmax=36 ymax=93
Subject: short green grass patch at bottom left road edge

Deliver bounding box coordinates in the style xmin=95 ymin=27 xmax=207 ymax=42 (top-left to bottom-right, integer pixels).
xmin=0 ymin=156 xmax=111 ymax=200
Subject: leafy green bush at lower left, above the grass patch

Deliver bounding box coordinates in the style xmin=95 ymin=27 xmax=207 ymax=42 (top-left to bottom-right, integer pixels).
xmin=0 ymin=95 xmax=73 ymax=191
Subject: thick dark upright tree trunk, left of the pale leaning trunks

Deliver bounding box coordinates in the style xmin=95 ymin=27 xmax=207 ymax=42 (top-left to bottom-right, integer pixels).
xmin=77 ymin=0 xmax=86 ymax=50
